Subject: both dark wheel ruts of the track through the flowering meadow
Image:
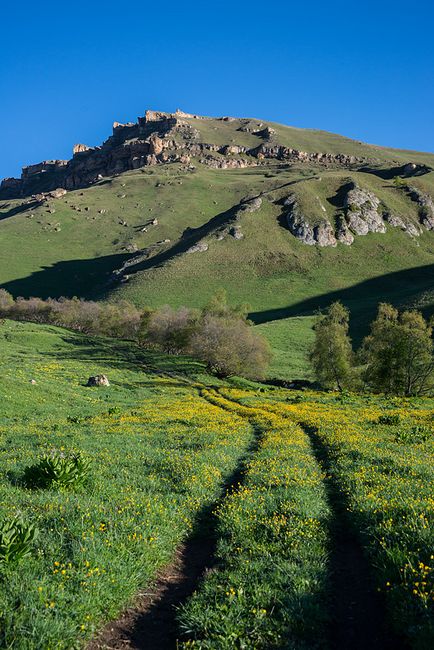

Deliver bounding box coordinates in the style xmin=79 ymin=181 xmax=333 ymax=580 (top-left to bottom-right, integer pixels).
xmin=89 ymin=389 xmax=405 ymax=650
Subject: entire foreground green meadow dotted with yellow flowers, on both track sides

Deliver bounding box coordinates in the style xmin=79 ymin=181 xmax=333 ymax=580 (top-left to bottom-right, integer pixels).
xmin=0 ymin=321 xmax=434 ymax=650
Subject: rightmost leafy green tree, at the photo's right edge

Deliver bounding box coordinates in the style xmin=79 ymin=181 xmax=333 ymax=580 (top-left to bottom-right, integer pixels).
xmin=362 ymin=303 xmax=434 ymax=396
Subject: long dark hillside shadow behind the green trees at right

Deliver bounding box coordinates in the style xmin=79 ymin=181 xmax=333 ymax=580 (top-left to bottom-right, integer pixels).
xmin=249 ymin=264 xmax=434 ymax=341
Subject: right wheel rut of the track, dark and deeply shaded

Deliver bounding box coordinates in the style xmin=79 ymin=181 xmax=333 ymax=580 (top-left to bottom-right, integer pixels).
xmin=304 ymin=427 xmax=407 ymax=650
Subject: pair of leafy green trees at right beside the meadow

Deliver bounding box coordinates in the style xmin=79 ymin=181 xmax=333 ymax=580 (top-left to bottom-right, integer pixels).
xmin=310 ymin=302 xmax=434 ymax=396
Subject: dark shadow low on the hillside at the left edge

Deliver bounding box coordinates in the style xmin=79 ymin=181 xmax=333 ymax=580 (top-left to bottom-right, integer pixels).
xmin=0 ymin=253 xmax=132 ymax=298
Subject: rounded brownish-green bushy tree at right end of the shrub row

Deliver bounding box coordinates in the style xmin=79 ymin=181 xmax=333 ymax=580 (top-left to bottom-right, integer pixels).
xmin=190 ymin=313 xmax=271 ymax=379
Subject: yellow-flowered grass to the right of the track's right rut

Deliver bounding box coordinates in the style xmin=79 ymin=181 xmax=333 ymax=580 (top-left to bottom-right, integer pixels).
xmin=253 ymin=394 xmax=434 ymax=650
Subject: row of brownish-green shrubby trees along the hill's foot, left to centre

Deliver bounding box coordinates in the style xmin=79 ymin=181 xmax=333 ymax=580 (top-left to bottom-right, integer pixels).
xmin=0 ymin=289 xmax=271 ymax=379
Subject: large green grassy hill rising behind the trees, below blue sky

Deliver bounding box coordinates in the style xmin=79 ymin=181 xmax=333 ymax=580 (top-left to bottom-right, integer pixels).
xmin=0 ymin=110 xmax=434 ymax=376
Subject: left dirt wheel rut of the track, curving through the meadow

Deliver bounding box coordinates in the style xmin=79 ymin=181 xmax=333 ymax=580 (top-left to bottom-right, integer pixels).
xmin=87 ymin=412 xmax=261 ymax=650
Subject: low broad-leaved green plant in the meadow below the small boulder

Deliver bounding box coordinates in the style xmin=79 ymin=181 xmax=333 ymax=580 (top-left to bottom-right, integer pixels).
xmin=24 ymin=452 xmax=90 ymax=489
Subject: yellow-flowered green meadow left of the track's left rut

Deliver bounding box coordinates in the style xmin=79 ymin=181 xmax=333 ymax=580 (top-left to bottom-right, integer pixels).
xmin=0 ymin=323 xmax=251 ymax=650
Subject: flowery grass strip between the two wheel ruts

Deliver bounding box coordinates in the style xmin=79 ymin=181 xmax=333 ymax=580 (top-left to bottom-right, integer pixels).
xmin=179 ymin=391 xmax=329 ymax=650
